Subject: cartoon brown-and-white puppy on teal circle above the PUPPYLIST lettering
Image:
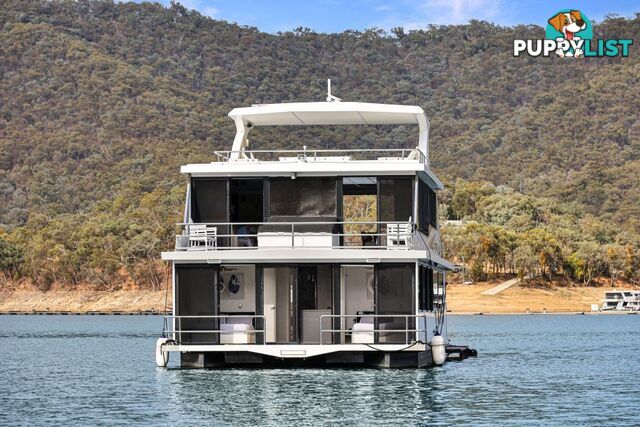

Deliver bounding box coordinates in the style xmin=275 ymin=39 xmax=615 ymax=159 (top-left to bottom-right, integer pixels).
xmin=546 ymin=9 xmax=593 ymax=58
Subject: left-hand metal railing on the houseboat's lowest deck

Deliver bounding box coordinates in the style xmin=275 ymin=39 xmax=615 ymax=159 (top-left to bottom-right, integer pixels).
xmin=162 ymin=314 xmax=267 ymax=345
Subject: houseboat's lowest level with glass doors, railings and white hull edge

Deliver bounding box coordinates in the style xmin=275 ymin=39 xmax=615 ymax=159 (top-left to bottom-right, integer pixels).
xmin=163 ymin=262 xmax=446 ymax=366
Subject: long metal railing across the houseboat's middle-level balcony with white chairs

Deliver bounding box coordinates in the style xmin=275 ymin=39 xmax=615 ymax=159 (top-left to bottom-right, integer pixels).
xmin=175 ymin=221 xmax=416 ymax=251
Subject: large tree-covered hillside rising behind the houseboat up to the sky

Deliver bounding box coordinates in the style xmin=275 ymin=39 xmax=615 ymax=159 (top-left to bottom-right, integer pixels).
xmin=0 ymin=0 xmax=640 ymax=287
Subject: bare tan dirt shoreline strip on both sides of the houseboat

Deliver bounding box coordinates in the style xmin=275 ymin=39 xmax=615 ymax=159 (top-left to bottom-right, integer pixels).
xmin=0 ymin=282 xmax=626 ymax=314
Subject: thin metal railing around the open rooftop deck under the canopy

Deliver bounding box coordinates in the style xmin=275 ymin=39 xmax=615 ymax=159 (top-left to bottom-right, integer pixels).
xmin=214 ymin=147 xmax=427 ymax=163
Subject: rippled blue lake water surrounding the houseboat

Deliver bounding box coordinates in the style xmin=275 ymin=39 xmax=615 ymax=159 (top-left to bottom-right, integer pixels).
xmin=0 ymin=315 xmax=640 ymax=425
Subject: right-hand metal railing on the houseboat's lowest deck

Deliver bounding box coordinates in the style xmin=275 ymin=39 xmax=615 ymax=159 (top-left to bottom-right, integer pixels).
xmin=320 ymin=313 xmax=427 ymax=344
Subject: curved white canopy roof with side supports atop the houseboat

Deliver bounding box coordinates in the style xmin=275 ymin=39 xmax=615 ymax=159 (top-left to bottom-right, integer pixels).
xmin=229 ymin=102 xmax=429 ymax=162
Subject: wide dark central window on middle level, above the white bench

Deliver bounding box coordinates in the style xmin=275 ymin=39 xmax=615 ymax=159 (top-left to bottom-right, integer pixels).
xmin=269 ymin=178 xmax=338 ymax=218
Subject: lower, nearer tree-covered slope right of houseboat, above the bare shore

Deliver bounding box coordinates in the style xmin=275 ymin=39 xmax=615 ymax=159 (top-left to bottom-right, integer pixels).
xmin=443 ymin=180 xmax=640 ymax=285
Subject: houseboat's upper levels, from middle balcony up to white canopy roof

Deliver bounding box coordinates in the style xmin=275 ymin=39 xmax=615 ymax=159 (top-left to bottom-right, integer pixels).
xmin=163 ymin=96 xmax=449 ymax=266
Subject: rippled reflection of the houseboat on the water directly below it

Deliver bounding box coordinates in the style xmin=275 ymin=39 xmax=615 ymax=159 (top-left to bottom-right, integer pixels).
xmin=156 ymin=369 xmax=443 ymax=425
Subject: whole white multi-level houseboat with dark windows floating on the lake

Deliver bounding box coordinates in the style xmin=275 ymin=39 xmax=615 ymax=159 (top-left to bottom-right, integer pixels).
xmin=156 ymin=89 xmax=453 ymax=368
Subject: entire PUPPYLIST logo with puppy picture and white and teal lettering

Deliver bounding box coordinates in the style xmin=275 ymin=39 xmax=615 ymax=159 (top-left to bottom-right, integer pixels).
xmin=513 ymin=9 xmax=633 ymax=58
